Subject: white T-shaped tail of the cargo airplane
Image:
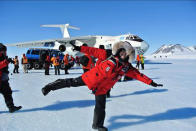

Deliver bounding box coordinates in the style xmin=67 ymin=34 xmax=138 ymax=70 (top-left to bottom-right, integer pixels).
xmin=41 ymin=24 xmax=80 ymax=38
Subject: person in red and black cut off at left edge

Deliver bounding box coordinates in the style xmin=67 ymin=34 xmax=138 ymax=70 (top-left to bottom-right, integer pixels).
xmin=0 ymin=43 xmax=22 ymax=113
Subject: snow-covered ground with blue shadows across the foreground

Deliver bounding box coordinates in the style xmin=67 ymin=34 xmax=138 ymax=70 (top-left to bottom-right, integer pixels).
xmin=0 ymin=60 xmax=196 ymax=131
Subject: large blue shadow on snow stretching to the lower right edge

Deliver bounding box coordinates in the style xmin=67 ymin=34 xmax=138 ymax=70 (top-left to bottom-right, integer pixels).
xmin=108 ymin=107 xmax=196 ymax=130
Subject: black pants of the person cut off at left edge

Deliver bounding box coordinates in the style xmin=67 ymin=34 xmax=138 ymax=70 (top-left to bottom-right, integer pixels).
xmin=0 ymin=81 xmax=14 ymax=108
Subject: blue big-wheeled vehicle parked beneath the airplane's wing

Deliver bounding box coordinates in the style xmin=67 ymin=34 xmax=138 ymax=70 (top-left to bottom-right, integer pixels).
xmin=26 ymin=48 xmax=64 ymax=69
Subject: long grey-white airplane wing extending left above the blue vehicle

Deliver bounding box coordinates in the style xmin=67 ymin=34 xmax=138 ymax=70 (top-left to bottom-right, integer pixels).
xmin=5 ymin=36 xmax=96 ymax=48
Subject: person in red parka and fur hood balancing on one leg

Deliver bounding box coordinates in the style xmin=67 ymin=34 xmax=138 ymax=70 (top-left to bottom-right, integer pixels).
xmin=42 ymin=41 xmax=163 ymax=131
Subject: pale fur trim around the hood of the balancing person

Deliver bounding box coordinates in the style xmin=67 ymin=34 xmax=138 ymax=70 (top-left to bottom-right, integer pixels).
xmin=112 ymin=41 xmax=135 ymax=63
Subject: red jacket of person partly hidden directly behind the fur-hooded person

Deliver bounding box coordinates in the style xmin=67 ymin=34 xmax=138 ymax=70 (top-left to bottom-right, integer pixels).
xmin=80 ymin=46 xmax=107 ymax=65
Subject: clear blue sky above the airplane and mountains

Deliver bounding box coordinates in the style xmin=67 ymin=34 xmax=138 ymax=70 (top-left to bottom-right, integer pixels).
xmin=0 ymin=0 xmax=196 ymax=54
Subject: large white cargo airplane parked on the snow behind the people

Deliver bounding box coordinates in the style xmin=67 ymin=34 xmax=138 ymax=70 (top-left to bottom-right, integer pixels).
xmin=6 ymin=24 xmax=149 ymax=56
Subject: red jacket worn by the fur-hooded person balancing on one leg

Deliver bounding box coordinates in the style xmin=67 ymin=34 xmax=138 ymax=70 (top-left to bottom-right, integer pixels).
xmin=82 ymin=57 xmax=152 ymax=95
